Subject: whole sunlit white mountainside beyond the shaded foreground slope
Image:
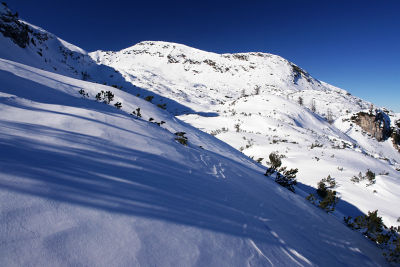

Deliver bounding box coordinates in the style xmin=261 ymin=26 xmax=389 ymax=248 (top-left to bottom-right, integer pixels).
xmin=90 ymin=42 xmax=400 ymax=225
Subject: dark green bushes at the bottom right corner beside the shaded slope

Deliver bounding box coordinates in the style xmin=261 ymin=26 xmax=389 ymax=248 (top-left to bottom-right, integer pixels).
xmin=344 ymin=213 xmax=400 ymax=263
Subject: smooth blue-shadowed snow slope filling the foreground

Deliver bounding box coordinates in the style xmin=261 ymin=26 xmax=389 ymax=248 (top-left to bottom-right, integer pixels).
xmin=0 ymin=59 xmax=385 ymax=266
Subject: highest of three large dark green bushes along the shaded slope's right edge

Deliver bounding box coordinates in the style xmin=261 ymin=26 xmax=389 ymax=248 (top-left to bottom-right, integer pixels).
xmin=264 ymin=152 xmax=298 ymax=193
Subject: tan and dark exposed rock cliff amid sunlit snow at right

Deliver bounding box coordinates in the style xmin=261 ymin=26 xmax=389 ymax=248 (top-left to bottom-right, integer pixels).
xmin=352 ymin=111 xmax=392 ymax=141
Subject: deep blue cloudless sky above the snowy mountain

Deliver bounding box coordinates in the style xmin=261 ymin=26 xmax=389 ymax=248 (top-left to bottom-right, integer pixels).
xmin=5 ymin=0 xmax=400 ymax=112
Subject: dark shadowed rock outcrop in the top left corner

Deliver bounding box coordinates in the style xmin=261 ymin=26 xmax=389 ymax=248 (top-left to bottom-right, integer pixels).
xmin=0 ymin=4 xmax=31 ymax=48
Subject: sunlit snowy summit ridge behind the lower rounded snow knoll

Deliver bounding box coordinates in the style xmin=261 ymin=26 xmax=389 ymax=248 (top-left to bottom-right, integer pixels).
xmin=89 ymin=41 xmax=369 ymax=116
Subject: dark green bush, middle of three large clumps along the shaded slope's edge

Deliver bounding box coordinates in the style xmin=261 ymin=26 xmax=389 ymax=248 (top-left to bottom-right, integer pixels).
xmin=306 ymin=175 xmax=339 ymax=213
